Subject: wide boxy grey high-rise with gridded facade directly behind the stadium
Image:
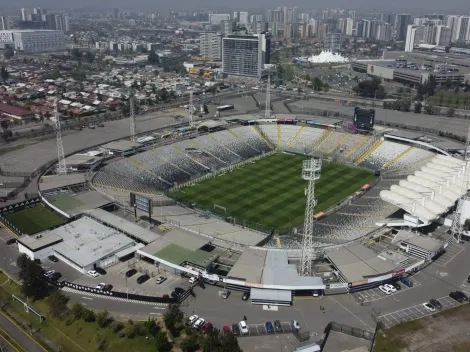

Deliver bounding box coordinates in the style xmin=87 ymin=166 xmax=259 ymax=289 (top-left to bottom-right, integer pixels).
xmin=222 ymin=34 xmax=268 ymax=78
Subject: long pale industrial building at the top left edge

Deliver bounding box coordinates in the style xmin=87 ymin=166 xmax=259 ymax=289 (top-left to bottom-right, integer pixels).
xmin=0 ymin=29 xmax=65 ymax=53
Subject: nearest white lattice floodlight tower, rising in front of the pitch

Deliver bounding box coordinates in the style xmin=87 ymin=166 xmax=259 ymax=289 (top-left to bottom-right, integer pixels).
xmin=299 ymin=158 xmax=322 ymax=276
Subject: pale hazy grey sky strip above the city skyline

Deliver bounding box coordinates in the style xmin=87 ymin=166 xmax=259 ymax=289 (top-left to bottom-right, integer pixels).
xmin=8 ymin=0 xmax=470 ymax=14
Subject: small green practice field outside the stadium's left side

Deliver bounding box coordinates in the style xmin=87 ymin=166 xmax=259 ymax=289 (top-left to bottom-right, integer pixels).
xmin=5 ymin=205 xmax=64 ymax=235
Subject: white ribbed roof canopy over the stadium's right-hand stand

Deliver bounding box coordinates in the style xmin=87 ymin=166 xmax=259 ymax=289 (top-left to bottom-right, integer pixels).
xmin=380 ymin=155 xmax=469 ymax=223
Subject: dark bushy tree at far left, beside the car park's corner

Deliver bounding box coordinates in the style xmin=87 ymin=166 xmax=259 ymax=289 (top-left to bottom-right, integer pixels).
xmin=16 ymin=254 xmax=48 ymax=299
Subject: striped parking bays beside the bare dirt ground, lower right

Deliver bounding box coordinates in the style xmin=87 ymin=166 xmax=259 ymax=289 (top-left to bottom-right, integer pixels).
xmin=379 ymin=296 xmax=467 ymax=329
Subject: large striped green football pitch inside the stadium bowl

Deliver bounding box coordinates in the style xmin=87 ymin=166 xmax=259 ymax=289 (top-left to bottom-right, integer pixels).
xmin=174 ymin=154 xmax=375 ymax=229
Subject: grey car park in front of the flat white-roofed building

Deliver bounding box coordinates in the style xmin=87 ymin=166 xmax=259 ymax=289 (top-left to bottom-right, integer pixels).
xmin=72 ymin=260 xmax=190 ymax=296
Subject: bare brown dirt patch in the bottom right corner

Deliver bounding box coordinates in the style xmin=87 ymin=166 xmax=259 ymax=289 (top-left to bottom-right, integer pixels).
xmin=374 ymin=304 xmax=470 ymax=352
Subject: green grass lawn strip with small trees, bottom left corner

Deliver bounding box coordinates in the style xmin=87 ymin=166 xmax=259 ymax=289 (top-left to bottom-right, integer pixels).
xmin=0 ymin=272 xmax=160 ymax=352
